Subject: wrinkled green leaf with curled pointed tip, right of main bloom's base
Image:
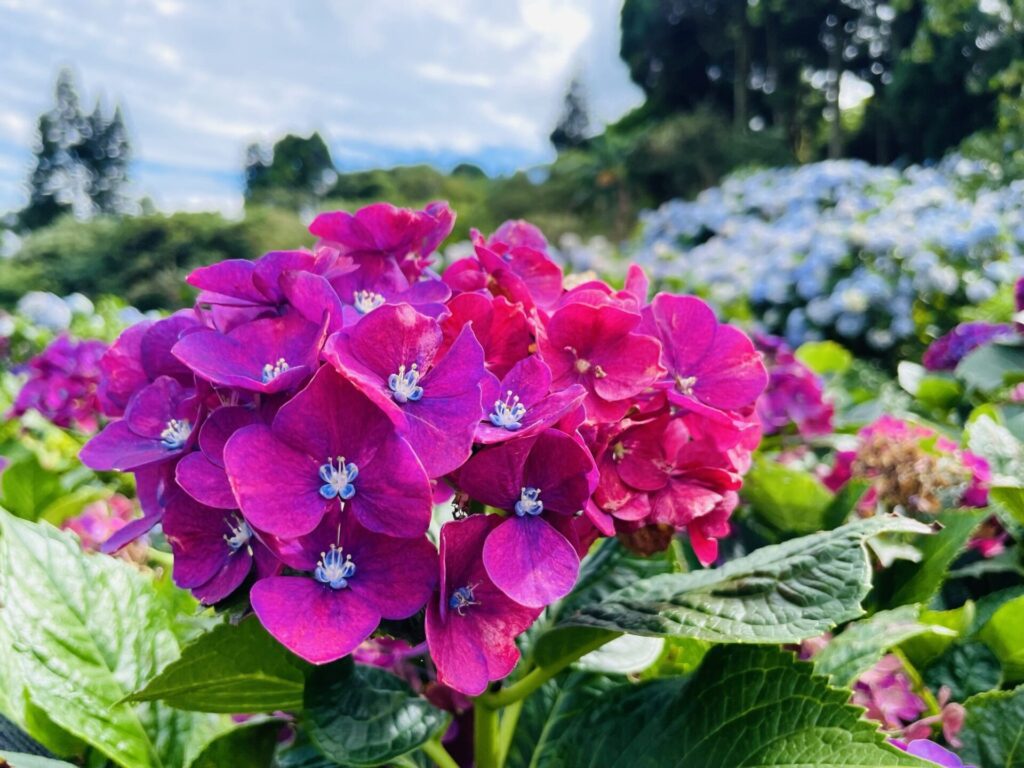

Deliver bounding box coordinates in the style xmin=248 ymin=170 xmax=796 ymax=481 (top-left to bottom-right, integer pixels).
xmin=567 ymin=516 xmax=930 ymax=643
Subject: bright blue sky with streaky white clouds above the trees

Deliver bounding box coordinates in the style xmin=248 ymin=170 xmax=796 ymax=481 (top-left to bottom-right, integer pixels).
xmin=0 ymin=0 xmax=642 ymax=213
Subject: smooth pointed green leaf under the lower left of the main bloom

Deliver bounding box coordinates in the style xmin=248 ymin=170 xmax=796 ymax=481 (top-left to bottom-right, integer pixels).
xmin=129 ymin=616 xmax=308 ymax=714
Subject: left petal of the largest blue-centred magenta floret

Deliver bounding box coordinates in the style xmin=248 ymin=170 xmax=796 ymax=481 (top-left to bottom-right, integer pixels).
xmin=224 ymin=424 xmax=327 ymax=538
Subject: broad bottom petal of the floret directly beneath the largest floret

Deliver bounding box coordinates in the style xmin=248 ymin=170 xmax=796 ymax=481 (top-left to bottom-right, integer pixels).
xmin=250 ymin=577 xmax=380 ymax=664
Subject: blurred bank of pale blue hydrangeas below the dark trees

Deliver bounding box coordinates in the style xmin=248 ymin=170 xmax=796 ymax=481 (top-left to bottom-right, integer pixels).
xmin=633 ymin=161 xmax=1024 ymax=354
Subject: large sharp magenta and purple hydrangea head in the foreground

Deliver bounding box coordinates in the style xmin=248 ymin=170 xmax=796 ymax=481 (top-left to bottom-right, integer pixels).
xmin=82 ymin=204 xmax=767 ymax=694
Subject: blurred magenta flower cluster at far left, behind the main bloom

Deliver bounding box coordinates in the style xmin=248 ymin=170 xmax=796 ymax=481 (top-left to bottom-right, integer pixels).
xmin=10 ymin=334 xmax=106 ymax=432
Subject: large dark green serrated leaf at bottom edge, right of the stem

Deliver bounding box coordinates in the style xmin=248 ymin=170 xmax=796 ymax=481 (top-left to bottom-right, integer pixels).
xmin=535 ymin=645 xmax=928 ymax=768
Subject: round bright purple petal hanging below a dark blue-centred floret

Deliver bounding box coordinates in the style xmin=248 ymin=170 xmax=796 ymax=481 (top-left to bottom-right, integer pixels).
xmin=483 ymin=516 xmax=580 ymax=608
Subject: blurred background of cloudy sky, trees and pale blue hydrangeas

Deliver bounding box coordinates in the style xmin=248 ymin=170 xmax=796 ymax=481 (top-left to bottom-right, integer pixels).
xmin=0 ymin=0 xmax=1024 ymax=365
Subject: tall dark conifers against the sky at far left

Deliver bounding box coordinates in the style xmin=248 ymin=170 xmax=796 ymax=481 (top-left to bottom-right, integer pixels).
xmin=18 ymin=70 xmax=130 ymax=229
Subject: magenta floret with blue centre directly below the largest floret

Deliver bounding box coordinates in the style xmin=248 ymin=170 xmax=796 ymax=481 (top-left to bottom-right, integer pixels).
xmin=250 ymin=513 xmax=437 ymax=664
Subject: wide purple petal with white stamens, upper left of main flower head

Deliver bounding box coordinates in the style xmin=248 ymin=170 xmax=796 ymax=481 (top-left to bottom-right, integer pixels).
xmin=171 ymin=313 xmax=327 ymax=394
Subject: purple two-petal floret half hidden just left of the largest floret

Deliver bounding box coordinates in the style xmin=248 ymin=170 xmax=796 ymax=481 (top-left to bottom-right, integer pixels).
xmin=175 ymin=406 xmax=260 ymax=509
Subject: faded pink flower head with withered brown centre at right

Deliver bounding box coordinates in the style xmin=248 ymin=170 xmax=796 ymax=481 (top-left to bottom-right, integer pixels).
xmin=824 ymin=416 xmax=991 ymax=516
